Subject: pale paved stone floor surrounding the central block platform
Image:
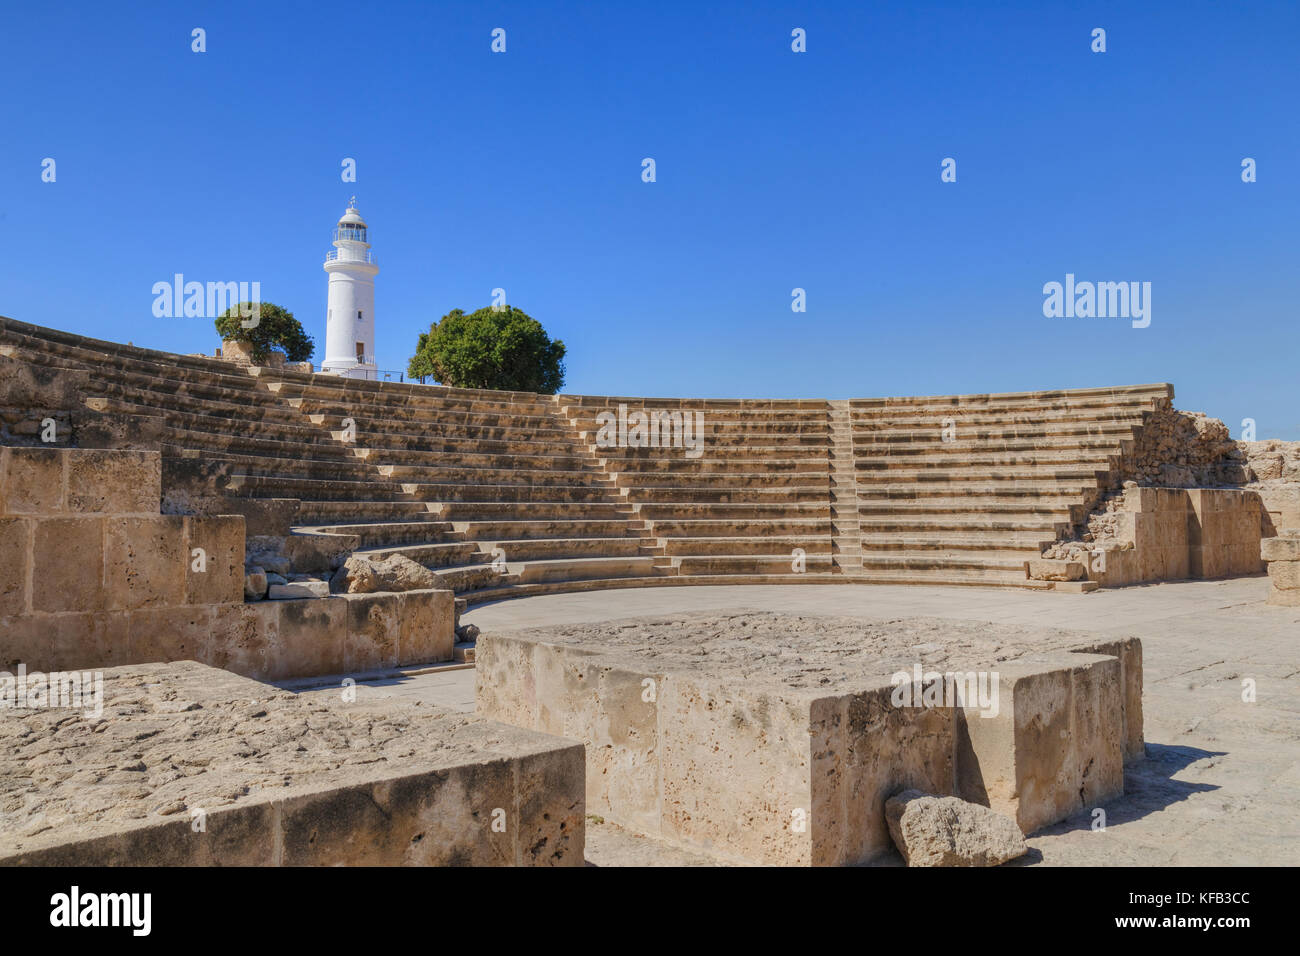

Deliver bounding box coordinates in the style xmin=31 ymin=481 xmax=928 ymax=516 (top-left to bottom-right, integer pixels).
xmin=297 ymin=578 xmax=1300 ymax=866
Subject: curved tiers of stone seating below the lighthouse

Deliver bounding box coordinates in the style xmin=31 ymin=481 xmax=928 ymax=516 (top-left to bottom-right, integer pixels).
xmin=0 ymin=319 xmax=1173 ymax=602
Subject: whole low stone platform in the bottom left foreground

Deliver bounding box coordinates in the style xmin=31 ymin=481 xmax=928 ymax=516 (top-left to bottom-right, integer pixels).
xmin=0 ymin=662 xmax=585 ymax=866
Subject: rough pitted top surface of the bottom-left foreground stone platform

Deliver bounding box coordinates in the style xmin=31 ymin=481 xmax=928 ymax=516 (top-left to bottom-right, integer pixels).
xmin=0 ymin=662 xmax=581 ymax=862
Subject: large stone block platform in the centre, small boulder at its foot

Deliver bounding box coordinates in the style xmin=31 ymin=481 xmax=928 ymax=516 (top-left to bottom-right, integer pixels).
xmin=476 ymin=613 xmax=1143 ymax=865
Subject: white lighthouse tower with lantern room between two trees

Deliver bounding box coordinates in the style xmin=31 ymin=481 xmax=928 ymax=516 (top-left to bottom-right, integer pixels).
xmin=321 ymin=196 xmax=380 ymax=378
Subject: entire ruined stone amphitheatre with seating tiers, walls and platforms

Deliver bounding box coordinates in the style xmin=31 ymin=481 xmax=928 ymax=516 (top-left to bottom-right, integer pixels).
xmin=0 ymin=319 xmax=1300 ymax=865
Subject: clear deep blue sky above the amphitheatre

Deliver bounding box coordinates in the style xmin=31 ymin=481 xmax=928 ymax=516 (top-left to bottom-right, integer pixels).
xmin=0 ymin=0 xmax=1300 ymax=438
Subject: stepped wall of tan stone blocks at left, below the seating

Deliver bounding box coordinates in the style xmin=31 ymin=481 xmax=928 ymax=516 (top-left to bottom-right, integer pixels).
xmin=0 ymin=447 xmax=455 ymax=679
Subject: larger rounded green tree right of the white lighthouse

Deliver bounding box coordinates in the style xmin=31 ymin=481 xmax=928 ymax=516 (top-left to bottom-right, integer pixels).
xmin=407 ymin=306 xmax=566 ymax=395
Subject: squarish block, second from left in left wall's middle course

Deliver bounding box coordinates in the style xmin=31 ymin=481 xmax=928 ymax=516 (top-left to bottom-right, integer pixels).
xmin=31 ymin=515 xmax=105 ymax=611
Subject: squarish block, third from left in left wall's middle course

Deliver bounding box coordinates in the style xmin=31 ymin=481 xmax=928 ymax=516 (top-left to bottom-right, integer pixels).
xmin=104 ymin=515 xmax=189 ymax=610
